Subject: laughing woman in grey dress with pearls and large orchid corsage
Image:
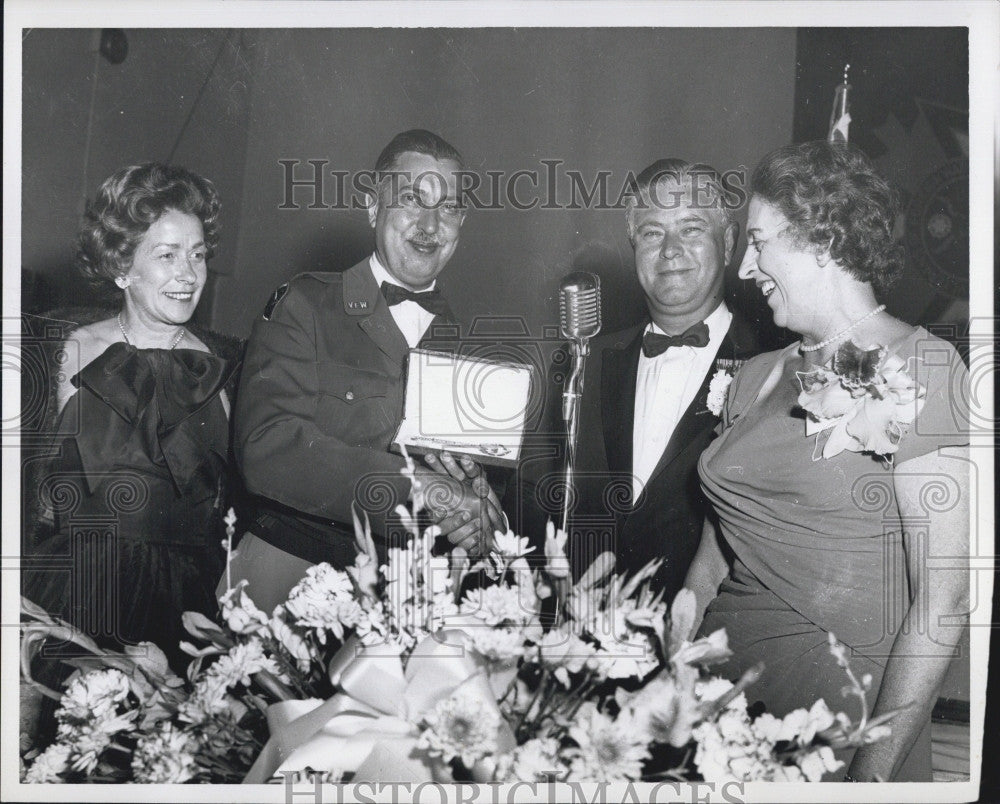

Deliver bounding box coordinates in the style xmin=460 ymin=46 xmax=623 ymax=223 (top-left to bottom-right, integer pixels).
xmin=687 ymin=142 xmax=970 ymax=782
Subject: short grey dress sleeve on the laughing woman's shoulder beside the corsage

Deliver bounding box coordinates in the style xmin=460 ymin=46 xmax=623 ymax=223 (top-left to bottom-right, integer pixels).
xmin=894 ymin=330 xmax=970 ymax=466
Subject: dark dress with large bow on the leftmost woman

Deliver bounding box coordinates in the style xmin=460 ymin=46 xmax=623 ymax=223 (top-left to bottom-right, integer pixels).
xmin=23 ymin=343 xmax=236 ymax=671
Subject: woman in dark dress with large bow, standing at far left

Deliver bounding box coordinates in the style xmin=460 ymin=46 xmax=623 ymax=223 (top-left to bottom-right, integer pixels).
xmin=23 ymin=163 xmax=239 ymax=671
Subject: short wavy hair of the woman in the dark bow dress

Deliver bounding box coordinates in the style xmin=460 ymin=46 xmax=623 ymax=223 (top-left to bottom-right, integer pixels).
xmin=76 ymin=162 xmax=221 ymax=290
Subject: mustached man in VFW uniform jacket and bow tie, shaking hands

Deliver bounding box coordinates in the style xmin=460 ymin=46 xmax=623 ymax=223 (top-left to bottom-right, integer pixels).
xmin=233 ymin=130 xmax=502 ymax=611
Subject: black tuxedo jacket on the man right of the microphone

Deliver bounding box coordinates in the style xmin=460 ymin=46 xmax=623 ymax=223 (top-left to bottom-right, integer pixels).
xmin=571 ymin=312 xmax=759 ymax=601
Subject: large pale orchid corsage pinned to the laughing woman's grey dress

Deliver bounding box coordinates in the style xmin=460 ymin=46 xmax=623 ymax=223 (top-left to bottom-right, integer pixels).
xmin=796 ymin=341 xmax=926 ymax=463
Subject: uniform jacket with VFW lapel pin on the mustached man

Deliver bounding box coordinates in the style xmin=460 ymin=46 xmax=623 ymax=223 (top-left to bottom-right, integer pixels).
xmin=234 ymin=259 xmax=457 ymax=567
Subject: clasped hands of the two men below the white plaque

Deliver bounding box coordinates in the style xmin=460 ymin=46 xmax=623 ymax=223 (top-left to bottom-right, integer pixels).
xmin=414 ymin=452 xmax=507 ymax=556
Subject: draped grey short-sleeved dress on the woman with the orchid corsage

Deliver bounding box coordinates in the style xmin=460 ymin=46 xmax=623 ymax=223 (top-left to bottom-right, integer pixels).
xmin=699 ymin=327 xmax=969 ymax=781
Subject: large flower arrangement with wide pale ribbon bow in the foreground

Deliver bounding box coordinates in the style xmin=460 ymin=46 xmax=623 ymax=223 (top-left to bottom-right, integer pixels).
xmin=22 ymin=452 xmax=889 ymax=783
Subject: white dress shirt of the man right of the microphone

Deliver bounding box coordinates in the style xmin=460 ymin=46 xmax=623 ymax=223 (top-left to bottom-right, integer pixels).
xmin=632 ymin=302 xmax=733 ymax=500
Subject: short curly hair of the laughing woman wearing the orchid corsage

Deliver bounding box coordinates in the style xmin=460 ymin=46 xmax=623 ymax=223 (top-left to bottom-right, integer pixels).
xmin=750 ymin=140 xmax=905 ymax=294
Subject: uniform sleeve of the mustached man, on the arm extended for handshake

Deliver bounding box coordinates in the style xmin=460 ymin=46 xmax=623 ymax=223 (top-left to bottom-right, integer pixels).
xmin=235 ymin=280 xmax=410 ymax=532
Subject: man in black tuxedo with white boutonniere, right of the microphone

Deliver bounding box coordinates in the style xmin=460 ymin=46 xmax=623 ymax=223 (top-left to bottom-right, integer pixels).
xmin=556 ymin=159 xmax=758 ymax=601
